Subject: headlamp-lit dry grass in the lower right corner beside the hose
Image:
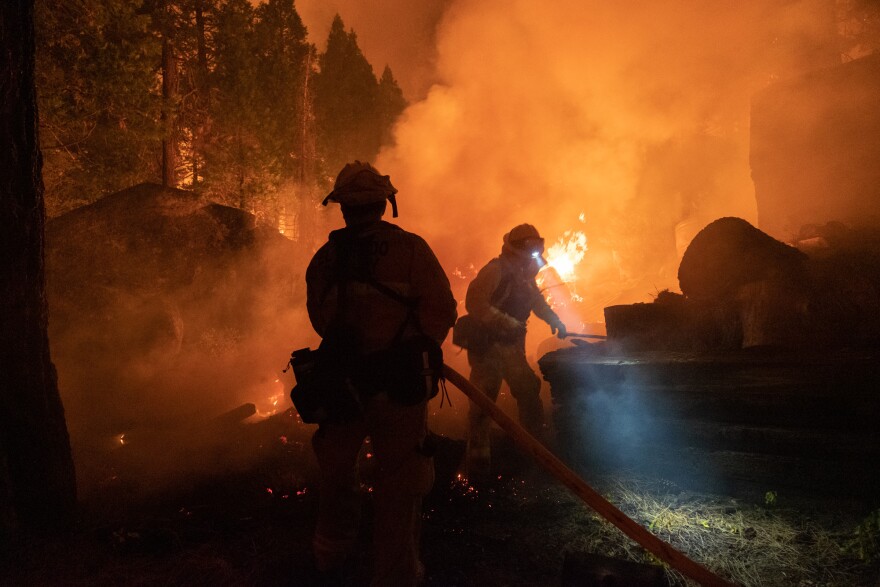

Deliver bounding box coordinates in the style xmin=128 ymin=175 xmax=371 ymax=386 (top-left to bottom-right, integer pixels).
xmin=524 ymin=479 xmax=880 ymax=587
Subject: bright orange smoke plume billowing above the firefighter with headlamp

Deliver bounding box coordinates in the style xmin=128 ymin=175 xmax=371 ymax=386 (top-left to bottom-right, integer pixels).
xmin=372 ymin=0 xmax=833 ymax=322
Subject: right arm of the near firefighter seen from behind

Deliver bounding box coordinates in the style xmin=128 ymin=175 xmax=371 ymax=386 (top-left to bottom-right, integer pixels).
xmin=412 ymin=239 xmax=458 ymax=342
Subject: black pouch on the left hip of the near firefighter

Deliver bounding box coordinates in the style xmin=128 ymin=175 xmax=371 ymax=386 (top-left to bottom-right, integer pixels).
xmin=290 ymin=348 xmax=362 ymax=424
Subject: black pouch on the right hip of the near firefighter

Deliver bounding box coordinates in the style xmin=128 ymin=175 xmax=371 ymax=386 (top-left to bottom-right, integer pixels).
xmin=364 ymin=335 xmax=443 ymax=406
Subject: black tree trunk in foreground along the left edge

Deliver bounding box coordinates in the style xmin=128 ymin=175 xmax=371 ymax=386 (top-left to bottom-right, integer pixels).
xmin=0 ymin=0 xmax=76 ymax=537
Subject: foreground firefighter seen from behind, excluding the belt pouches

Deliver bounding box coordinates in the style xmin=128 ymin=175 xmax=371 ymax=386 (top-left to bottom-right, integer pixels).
xmin=306 ymin=161 xmax=456 ymax=586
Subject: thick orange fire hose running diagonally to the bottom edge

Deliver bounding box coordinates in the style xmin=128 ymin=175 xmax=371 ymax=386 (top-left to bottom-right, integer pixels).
xmin=443 ymin=365 xmax=734 ymax=587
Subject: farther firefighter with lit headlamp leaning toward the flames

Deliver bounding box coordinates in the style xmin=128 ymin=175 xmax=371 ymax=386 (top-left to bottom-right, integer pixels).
xmin=465 ymin=224 xmax=567 ymax=478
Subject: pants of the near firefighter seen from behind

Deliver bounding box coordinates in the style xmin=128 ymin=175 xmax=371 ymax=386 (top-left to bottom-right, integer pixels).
xmin=312 ymin=394 xmax=434 ymax=587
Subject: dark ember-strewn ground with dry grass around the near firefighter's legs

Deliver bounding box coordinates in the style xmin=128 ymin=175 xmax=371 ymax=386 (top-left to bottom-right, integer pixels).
xmin=0 ymin=411 xmax=880 ymax=587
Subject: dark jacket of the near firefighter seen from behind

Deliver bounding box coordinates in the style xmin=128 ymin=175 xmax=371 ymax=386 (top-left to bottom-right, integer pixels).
xmin=306 ymin=221 xmax=457 ymax=354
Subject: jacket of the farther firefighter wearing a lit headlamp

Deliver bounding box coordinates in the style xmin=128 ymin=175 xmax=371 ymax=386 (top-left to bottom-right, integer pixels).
xmin=465 ymin=252 xmax=560 ymax=342
